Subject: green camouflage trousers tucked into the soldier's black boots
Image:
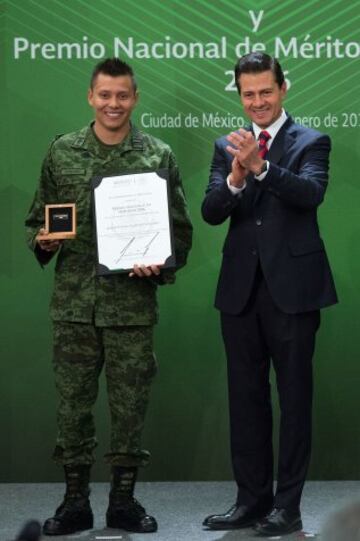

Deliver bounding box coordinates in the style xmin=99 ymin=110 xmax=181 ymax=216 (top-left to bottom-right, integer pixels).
xmin=53 ymin=322 xmax=157 ymax=466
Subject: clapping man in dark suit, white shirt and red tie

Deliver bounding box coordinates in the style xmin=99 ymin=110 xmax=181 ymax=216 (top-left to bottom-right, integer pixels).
xmin=202 ymin=53 xmax=337 ymax=536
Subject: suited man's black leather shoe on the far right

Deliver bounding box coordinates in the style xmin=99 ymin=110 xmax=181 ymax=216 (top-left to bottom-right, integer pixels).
xmin=254 ymin=507 xmax=302 ymax=537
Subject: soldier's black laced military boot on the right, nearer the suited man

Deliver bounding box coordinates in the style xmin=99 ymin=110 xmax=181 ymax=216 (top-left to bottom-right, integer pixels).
xmin=106 ymin=466 xmax=157 ymax=533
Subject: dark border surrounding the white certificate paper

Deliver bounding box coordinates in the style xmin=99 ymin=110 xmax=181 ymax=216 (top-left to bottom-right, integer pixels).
xmin=90 ymin=168 xmax=176 ymax=276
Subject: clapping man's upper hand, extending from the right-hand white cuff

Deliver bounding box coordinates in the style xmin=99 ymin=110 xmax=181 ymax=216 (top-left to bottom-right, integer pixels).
xmin=226 ymin=128 xmax=264 ymax=175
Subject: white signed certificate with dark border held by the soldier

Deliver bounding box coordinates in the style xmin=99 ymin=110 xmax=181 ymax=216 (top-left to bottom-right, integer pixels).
xmin=91 ymin=169 xmax=175 ymax=274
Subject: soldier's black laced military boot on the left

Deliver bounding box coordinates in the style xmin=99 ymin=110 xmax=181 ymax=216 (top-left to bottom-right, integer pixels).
xmin=43 ymin=464 xmax=94 ymax=535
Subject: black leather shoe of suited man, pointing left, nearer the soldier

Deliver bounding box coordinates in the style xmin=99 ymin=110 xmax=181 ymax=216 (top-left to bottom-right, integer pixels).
xmin=203 ymin=504 xmax=269 ymax=530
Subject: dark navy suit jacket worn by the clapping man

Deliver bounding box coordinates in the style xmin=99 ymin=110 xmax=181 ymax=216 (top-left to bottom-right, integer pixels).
xmin=202 ymin=117 xmax=337 ymax=314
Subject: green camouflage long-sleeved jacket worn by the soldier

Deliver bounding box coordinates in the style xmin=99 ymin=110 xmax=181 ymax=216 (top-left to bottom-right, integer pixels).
xmin=25 ymin=126 xmax=192 ymax=326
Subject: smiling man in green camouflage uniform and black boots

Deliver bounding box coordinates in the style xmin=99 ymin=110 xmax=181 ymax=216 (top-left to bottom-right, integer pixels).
xmin=26 ymin=58 xmax=192 ymax=535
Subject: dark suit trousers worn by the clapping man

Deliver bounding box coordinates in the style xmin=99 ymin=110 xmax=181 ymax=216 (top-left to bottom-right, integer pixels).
xmin=221 ymin=270 xmax=320 ymax=510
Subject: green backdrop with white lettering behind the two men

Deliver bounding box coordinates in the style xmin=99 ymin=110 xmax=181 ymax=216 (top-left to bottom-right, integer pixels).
xmin=0 ymin=0 xmax=360 ymax=481
